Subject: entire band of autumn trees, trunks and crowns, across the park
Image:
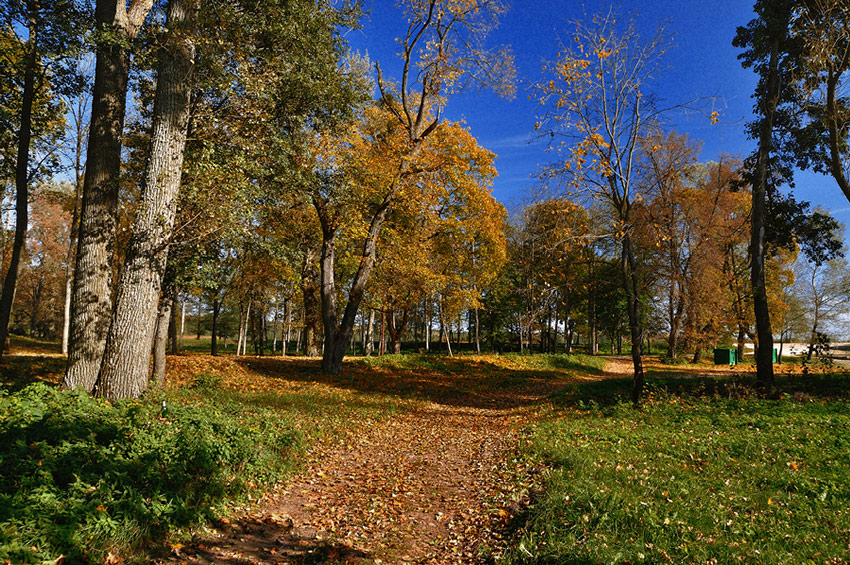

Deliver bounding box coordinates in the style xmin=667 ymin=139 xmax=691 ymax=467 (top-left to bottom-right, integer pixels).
xmin=0 ymin=0 xmax=850 ymax=402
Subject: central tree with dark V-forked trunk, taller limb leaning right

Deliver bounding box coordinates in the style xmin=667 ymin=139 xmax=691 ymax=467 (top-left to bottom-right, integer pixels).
xmin=313 ymin=0 xmax=513 ymax=373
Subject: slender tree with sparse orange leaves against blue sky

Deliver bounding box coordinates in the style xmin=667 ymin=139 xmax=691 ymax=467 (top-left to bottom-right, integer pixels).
xmin=536 ymin=12 xmax=684 ymax=403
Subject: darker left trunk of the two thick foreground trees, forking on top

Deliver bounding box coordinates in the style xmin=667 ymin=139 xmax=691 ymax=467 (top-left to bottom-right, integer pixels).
xmin=62 ymin=0 xmax=153 ymax=391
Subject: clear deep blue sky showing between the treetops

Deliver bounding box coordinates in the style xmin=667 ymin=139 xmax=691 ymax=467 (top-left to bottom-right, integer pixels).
xmin=347 ymin=0 xmax=850 ymax=218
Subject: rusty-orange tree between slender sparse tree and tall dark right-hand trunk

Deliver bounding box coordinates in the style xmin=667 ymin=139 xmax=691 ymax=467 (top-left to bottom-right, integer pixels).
xmin=638 ymin=132 xmax=749 ymax=358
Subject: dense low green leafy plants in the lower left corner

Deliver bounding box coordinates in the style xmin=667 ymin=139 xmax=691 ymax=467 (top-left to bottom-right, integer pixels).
xmin=0 ymin=384 xmax=300 ymax=563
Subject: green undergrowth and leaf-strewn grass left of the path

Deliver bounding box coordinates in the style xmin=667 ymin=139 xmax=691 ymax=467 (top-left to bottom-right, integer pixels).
xmin=0 ymin=355 xmax=406 ymax=563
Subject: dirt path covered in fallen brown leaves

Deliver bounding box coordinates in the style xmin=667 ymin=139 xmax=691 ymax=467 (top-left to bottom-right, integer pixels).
xmin=152 ymin=360 xmax=626 ymax=565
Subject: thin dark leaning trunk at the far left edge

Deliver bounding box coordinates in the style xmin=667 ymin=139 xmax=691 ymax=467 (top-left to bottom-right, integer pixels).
xmin=0 ymin=16 xmax=40 ymax=357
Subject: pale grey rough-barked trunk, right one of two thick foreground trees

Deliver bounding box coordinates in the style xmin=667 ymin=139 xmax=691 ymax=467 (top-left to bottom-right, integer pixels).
xmin=95 ymin=0 xmax=197 ymax=400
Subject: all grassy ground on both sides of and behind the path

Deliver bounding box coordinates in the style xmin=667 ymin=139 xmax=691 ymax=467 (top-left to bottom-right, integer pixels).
xmin=0 ymin=342 xmax=850 ymax=564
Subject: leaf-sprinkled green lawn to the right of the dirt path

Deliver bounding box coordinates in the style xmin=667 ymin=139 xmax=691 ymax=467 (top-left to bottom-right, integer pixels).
xmin=504 ymin=382 xmax=850 ymax=564
